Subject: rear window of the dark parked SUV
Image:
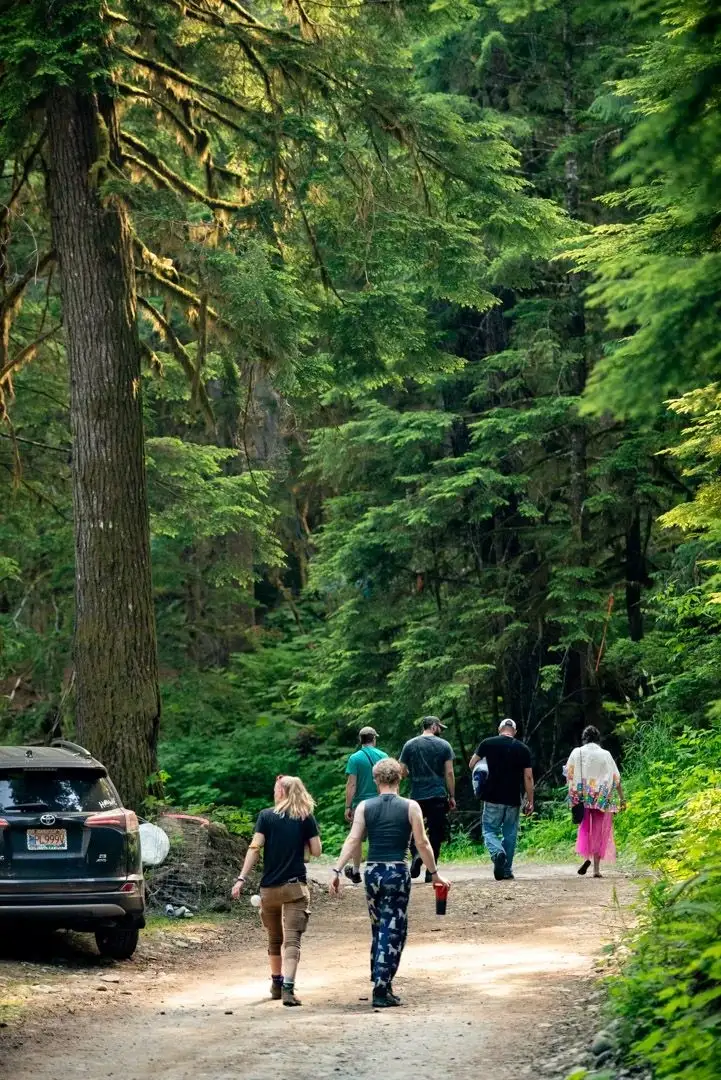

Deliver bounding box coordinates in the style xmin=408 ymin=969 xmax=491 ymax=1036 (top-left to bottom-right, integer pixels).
xmin=0 ymin=769 xmax=119 ymax=813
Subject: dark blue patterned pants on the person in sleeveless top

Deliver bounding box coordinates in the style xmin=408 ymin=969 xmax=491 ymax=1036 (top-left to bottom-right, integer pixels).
xmin=366 ymin=863 xmax=410 ymax=993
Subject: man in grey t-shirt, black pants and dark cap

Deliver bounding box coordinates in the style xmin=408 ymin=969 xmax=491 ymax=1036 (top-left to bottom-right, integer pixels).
xmin=398 ymin=716 xmax=455 ymax=881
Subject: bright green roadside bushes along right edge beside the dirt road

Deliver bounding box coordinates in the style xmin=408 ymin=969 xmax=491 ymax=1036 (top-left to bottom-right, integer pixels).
xmin=595 ymin=579 xmax=721 ymax=1080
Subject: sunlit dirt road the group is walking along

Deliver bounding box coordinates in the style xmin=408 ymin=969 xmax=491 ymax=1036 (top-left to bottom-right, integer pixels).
xmin=2 ymin=865 xmax=634 ymax=1080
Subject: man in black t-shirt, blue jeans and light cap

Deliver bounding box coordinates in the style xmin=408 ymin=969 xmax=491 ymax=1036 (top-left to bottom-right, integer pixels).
xmin=468 ymin=719 xmax=533 ymax=881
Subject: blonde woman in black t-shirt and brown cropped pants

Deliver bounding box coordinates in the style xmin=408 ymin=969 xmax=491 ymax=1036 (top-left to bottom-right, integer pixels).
xmin=232 ymin=777 xmax=322 ymax=1005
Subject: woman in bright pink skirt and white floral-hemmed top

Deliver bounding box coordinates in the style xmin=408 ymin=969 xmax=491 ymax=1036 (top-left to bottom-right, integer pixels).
xmin=563 ymin=727 xmax=626 ymax=877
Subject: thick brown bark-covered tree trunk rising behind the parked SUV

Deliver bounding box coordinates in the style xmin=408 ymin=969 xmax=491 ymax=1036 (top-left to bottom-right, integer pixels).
xmin=47 ymin=87 xmax=160 ymax=807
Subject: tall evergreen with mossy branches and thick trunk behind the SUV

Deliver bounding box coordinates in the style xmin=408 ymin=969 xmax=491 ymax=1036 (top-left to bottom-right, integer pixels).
xmin=2 ymin=0 xmax=557 ymax=801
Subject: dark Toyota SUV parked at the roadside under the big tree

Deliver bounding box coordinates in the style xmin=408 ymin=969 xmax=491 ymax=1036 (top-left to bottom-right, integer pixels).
xmin=0 ymin=742 xmax=145 ymax=960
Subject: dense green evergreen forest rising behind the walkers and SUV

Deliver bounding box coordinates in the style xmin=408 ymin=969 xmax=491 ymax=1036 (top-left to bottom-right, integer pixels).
xmin=0 ymin=0 xmax=721 ymax=1080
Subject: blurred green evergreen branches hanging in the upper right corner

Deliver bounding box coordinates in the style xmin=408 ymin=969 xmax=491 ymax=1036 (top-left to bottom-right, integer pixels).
xmin=576 ymin=0 xmax=721 ymax=415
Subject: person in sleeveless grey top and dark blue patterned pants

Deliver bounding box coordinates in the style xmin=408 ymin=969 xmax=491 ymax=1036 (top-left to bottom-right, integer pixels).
xmin=330 ymin=757 xmax=448 ymax=1009
